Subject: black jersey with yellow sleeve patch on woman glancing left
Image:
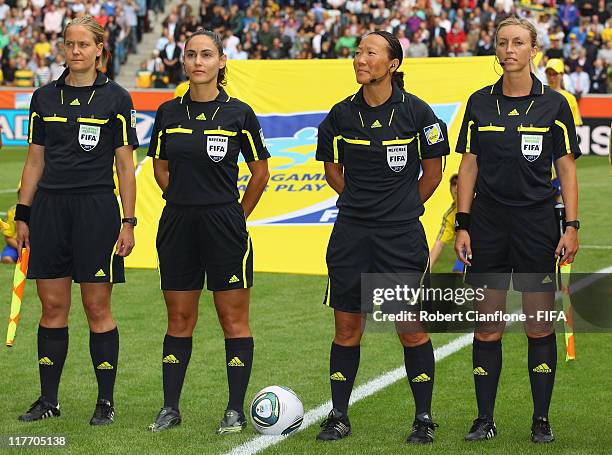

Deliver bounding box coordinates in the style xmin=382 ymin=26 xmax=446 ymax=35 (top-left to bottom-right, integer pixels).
xmin=316 ymin=84 xmax=449 ymax=224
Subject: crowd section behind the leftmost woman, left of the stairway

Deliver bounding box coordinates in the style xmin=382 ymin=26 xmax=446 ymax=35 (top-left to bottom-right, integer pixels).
xmin=0 ymin=0 xmax=149 ymax=87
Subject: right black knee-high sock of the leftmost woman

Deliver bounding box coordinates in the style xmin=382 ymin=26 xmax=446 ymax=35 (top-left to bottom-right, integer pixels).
xmin=89 ymin=327 xmax=119 ymax=404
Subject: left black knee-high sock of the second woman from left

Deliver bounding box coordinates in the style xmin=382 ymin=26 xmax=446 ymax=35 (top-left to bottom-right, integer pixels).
xmin=162 ymin=335 xmax=192 ymax=410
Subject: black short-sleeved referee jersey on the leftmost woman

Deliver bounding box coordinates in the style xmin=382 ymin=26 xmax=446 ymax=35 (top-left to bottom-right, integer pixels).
xmin=28 ymin=69 xmax=138 ymax=191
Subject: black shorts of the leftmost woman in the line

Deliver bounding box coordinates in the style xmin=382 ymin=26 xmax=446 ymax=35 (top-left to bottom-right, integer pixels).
xmin=28 ymin=189 xmax=125 ymax=283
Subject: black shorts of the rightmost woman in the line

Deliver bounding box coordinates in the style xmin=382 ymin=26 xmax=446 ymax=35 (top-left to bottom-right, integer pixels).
xmin=466 ymin=195 xmax=560 ymax=292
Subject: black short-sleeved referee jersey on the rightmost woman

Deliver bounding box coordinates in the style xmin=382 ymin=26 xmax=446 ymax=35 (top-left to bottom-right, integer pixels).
xmin=456 ymin=74 xmax=580 ymax=207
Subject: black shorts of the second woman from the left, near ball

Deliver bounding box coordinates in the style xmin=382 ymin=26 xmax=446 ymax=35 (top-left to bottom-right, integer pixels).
xmin=157 ymin=202 xmax=253 ymax=291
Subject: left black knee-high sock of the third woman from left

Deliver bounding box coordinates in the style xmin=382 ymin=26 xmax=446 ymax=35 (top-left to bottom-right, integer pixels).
xmin=329 ymin=343 xmax=361 ymax=415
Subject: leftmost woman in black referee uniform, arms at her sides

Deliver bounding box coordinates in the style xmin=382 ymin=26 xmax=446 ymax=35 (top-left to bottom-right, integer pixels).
xmin=15 ymin=16 xmax=138 ymax=425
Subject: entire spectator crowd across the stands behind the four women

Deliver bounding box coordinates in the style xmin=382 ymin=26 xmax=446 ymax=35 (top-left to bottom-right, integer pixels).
xmin=0 ymin=0 xmax=612 ymax=96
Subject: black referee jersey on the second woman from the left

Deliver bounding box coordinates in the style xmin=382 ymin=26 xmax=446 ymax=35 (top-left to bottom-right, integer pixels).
xmin=148 ymin=89 xmax=270 ymax=205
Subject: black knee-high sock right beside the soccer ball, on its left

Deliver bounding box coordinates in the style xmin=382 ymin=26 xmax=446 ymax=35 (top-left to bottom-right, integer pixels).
xmin=225 ymin=337 xmax=254 ymax=412
